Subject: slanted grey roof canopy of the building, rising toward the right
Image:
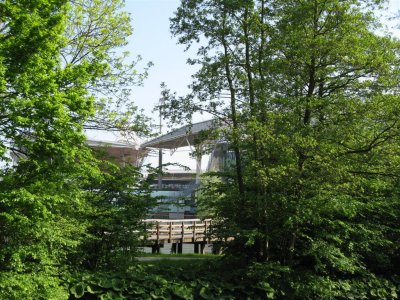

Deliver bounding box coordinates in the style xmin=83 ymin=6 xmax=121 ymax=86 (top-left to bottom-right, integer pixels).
xmin=141 ymin=120 xmax=215 ymax=150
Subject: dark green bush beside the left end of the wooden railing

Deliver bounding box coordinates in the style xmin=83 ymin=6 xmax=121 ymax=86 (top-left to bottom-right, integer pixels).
xmin=75 ymin=161 xmax=155 ymax=271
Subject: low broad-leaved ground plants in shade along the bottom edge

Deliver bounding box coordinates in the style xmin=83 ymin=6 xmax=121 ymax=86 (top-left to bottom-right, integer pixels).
xmin=70 ymin=258 xmax=399 ymax=299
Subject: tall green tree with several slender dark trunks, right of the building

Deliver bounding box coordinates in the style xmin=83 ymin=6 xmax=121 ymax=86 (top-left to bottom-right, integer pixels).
xmin=165 ymin=0 xmax=400 ymax=298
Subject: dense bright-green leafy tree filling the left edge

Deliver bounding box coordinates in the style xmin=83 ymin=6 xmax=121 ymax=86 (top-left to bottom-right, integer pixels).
xmin=0 ymin=0 xmax=93 ymax=299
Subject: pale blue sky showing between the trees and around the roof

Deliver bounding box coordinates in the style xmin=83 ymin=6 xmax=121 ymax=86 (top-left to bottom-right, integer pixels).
xmin=94 ymin=0 xmax=400 ymax=169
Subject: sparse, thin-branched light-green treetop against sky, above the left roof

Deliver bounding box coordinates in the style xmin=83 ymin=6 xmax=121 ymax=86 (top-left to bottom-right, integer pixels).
xmin=61 ymin=0 xmax=151 ymax=137
